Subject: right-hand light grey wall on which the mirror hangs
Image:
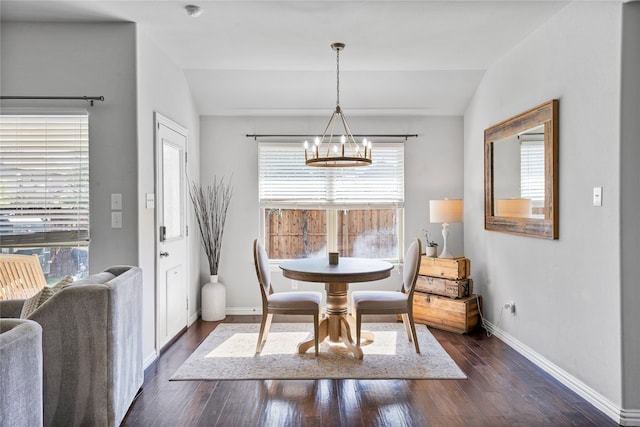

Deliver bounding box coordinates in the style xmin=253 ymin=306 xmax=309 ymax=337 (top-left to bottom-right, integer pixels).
xmin=464 ymin=2 xmax=624 ymax=409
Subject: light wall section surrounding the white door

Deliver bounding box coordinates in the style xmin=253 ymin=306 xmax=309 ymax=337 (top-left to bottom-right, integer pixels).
xmin=137 ymin=30 xmax=200 ymax=363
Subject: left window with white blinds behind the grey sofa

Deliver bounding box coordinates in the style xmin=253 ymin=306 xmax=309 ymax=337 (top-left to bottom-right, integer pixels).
xmin=0 ymin=114 xmax=89 ymax=282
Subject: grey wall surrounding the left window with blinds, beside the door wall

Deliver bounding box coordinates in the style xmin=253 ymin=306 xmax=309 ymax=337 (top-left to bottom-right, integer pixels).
xmin=0 ymin=22 xmax=138 ymax=273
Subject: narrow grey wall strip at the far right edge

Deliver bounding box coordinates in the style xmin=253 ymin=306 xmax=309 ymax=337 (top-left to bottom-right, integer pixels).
xmin=620 ymin=2 xmax=640 ymax=418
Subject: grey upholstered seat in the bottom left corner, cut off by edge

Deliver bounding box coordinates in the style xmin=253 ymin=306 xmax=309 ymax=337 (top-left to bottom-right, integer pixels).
xmin=0 ymin=319 xmax=42 ymax=427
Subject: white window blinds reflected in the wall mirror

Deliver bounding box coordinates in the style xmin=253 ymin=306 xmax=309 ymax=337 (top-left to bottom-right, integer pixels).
xmin=520 ymin=141 xmax=544 ymax=201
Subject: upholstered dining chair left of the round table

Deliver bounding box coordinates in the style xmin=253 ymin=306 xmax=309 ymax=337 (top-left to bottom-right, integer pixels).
xmin=253 ymin=239 xmax=322 ymax=356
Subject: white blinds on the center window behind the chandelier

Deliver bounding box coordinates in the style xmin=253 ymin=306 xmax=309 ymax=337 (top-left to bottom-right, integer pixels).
xmin=258 ymin=143 xmax=404 ymax=209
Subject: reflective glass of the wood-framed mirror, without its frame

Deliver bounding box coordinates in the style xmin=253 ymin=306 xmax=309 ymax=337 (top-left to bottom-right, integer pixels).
xmin=493 ymin=125 xmax=545 ymax=218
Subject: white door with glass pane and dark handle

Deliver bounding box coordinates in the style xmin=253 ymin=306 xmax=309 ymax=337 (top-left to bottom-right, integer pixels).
xmin=155 ymin=113 xmax=189 ymax=350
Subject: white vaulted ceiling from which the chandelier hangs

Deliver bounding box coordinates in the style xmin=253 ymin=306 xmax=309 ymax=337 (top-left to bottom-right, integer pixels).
xmin=0 ymin=0 xmax=568 ymax=115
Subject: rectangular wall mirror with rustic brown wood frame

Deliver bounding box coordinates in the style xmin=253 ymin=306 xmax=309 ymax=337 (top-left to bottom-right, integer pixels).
xmin=484 ymin=99 xmax=558 ymax=239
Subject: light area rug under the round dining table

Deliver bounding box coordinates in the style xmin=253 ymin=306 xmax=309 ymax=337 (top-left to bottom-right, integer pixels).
xmin=171 ymin=322 xmax=467 ymax=380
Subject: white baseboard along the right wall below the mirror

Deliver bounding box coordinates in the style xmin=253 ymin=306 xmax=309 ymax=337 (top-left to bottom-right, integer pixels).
xmin=484 ymin=320 xmax=640 ymax=426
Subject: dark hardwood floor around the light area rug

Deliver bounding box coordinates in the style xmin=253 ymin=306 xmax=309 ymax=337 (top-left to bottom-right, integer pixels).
xmin=122 ymin=316 xmax=617 ymax=427
